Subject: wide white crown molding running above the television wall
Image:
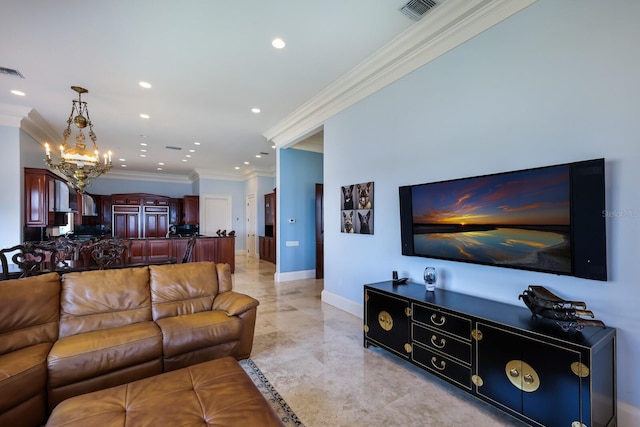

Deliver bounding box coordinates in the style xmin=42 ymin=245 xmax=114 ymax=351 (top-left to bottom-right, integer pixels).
xmin=263 ymin=0 xmax=538 ymax=147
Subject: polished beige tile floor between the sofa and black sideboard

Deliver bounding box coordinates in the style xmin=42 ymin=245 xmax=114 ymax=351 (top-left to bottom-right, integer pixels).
xmin=234 ymin=256 xmax=524 ymax=427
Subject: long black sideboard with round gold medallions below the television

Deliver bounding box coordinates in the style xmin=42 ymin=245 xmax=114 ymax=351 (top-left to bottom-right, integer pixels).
xmin=364 ymin=282 xmax=617 ymax=427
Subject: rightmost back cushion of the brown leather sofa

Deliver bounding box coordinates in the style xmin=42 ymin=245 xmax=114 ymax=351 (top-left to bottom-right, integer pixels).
xmin=149 ymin=262 xmax=218 ymax=320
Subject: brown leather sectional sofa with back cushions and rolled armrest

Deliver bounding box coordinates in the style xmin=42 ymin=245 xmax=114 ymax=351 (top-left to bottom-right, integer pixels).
xmin=0 ymin=262 xmax=258 ymax=426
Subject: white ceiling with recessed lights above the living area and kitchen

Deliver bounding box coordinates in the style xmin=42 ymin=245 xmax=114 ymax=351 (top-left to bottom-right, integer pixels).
xmin=0 ymin=0 xmax=415 ymax=178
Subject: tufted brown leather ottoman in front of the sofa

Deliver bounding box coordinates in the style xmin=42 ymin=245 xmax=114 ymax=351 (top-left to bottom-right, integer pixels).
xmin=46 ymin=357 xmax=283 ymax=427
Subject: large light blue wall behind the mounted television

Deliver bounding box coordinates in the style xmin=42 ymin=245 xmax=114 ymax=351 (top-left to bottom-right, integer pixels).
xmin=324 ymin=0 xmax=640 ymax=416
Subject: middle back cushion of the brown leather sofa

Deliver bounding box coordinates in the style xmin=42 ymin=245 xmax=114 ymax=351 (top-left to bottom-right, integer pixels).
xmin=60 ymin=267 xmax=151 ymax=338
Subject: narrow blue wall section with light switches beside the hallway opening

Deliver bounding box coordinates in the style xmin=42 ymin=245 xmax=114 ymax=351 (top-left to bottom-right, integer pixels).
xmin=277 ymin=149 xmax=323 ymax=273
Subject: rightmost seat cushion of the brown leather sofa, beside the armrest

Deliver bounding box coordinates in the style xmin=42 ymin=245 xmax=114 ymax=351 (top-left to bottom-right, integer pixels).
xmin=156 ymin=311 xmax=242 ymax=357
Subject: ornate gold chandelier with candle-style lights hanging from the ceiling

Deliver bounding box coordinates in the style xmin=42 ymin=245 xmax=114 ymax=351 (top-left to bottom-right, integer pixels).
xmin=44 ymin=86 xmax=112 ymax=193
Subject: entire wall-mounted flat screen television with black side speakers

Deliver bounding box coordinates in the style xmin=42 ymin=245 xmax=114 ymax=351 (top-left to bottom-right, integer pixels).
xmin=400 ymin=159 xmax=607 ymax=280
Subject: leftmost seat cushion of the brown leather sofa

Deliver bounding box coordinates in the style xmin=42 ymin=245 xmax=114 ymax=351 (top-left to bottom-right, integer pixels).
xmin=0 ymin=342 xmax=53 ymax=414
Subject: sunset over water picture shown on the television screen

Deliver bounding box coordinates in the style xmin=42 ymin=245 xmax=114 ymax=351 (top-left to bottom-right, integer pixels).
xmin=412 ymin=165 xmax=571 ymax=273
